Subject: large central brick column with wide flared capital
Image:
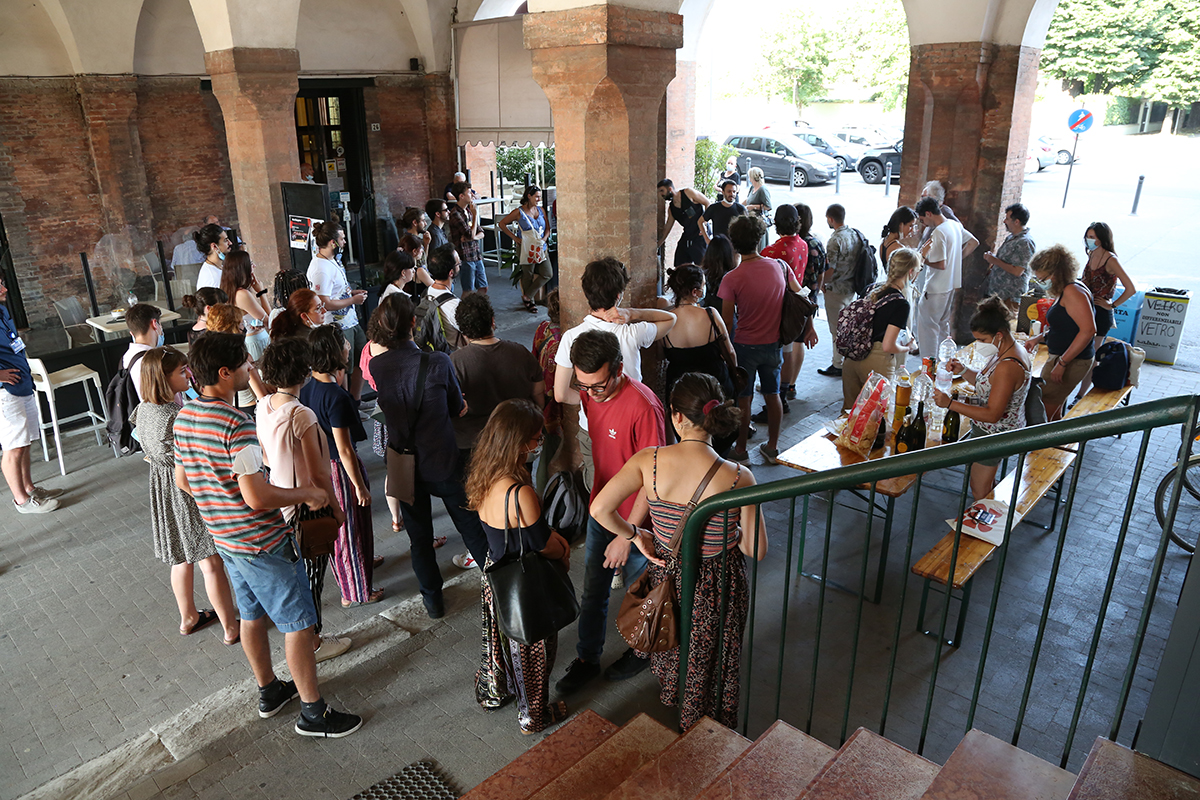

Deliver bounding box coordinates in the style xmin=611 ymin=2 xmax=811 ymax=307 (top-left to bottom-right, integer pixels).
xmin=524 ymin=5 xmax=683 ymax=327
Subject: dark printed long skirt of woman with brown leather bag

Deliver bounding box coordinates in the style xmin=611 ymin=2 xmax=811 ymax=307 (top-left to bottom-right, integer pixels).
xmin=647 ymin=541 xmax=750 ymax=730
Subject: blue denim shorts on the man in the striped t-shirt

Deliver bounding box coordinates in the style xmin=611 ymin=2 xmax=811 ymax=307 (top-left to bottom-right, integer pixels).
xmin=221 ymin=545 xmax=317 ymax=633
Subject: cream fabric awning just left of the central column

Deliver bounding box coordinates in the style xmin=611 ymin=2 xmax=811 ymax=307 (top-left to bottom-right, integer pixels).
xmin=454 ymin=16 xmax=554 ymax=146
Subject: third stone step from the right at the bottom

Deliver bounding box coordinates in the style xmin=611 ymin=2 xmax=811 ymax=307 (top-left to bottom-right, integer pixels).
xmin=798 ymin=728 xmax=937 ymax=800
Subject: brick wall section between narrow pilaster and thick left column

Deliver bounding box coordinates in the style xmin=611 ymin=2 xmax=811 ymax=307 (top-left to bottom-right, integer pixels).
xmin=137 ymin=77 xmax=238 ymax=247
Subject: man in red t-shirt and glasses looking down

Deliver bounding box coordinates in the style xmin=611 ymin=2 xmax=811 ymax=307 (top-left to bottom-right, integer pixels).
xmin=556 ymin=330 xmax=666 ymax=694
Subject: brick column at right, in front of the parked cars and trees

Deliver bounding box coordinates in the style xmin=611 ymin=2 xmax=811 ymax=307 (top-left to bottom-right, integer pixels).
xmin=900 ymin=42 xmax=1042 ymax=342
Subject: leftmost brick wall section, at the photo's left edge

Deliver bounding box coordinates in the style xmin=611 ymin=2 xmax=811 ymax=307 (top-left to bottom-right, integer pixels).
xmin=0 ymin=78 xmax=104 ymax=327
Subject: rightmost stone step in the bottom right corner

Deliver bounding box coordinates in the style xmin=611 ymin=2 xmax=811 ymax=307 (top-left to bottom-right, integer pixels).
xmin=1070 ymin=739 xmax=1200 ymax=800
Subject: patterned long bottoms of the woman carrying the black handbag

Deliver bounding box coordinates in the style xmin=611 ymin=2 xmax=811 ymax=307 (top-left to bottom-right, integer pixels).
xmin=475 ymin=559 xmax=558 ymax=733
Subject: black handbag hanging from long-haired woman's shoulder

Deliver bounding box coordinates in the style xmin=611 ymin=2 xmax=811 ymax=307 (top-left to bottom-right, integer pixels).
xmin=484 ymin=483 xmax=580 ymax=644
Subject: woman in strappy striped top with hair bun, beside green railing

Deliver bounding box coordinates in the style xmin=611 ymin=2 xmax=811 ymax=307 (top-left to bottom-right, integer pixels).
xmin=592 ymin=373 xmax=767 ymax=730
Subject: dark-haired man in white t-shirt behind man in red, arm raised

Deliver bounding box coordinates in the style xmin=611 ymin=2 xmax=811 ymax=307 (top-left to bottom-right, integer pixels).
xmin=554 ymin=257 xmax=676 ymax=489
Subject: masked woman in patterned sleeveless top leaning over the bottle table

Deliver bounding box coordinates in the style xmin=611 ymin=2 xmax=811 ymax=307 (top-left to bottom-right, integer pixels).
xmin=934 ymin=295 xmax=1033 ymax=500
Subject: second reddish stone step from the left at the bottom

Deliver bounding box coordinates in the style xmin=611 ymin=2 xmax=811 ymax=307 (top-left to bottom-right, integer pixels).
xmin=532 ymin=714 xmax=677 ymax=800
